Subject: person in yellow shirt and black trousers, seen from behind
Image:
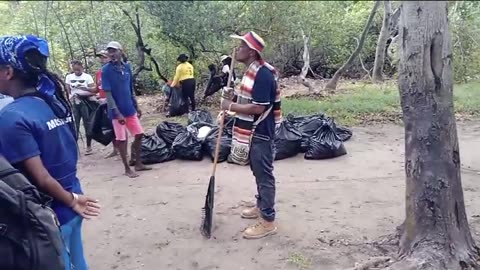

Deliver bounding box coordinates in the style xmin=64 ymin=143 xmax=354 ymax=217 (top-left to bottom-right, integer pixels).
xmin=170 ymin=53 xmax=195 ymax=112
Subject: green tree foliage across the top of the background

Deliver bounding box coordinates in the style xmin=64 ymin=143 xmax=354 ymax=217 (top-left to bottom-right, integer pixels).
xmin=0 ymin=1 xmax=480 ymax=85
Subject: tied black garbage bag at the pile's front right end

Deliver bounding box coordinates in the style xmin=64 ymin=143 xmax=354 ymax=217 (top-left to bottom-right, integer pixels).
xmin=305 ymin=119 xmax=347 ymax=159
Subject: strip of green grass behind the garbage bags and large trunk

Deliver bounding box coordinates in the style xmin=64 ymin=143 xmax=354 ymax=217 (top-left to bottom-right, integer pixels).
xmin=282 ymin=81 xmax=480 ymax=125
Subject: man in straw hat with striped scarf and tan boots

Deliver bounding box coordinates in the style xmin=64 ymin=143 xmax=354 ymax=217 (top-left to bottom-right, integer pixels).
xmin=222 ymin=32 xmax=281 ymax=239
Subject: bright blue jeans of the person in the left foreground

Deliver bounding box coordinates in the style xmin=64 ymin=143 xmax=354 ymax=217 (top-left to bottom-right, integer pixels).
xmin=60 ymin=216 xmax=88 ymax=270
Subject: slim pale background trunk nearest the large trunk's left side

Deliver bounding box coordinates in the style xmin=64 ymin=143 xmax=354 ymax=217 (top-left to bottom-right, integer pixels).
xmin=373 ymin=0 xmax=392 ymax=83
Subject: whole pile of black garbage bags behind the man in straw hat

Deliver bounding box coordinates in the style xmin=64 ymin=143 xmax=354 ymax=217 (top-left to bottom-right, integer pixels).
xmin=137 ymin=110 xmax=352 ymax=164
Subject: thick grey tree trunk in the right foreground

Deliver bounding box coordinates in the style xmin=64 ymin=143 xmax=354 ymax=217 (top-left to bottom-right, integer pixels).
xmin=394 ymin=1 xmax=479 ymax=270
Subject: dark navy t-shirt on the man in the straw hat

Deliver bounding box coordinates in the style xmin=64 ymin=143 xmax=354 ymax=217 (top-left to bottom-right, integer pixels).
xmin=252 ymin=67 xmax=277 ymax=139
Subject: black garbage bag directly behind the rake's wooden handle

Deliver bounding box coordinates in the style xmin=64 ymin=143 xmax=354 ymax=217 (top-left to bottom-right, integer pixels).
xmin=203 ymin=127 xmax=232 ymax=163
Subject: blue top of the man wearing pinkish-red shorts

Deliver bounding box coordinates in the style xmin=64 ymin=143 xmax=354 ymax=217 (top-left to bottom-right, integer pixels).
xmin=102 ymin=62 xmax=137 ymax=119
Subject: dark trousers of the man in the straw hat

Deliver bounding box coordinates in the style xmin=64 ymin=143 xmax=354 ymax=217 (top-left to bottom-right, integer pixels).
xmin=250 ymin=135 xmax=275 ymax=222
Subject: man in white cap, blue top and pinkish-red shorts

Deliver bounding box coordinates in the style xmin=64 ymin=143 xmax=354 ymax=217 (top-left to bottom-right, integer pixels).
xmin=102 ymin=41 xmax=151 ymax=178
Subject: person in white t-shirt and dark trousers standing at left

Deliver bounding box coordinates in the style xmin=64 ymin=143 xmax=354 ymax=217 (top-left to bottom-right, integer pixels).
xmin=65 ymin=60 xmax=98 ymax=155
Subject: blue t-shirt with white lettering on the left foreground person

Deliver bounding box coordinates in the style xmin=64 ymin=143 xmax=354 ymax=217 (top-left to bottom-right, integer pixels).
xmin=0 ymin=96 xmax=82 ymax=225
